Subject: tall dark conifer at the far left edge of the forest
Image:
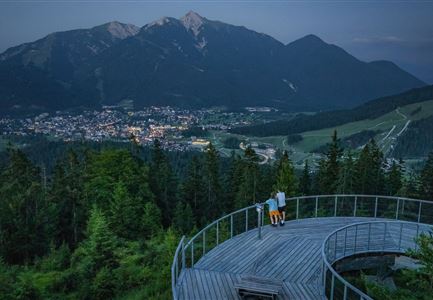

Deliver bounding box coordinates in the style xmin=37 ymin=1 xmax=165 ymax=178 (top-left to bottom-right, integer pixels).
xmin=0 ymin=149 xmax=47 ymax=263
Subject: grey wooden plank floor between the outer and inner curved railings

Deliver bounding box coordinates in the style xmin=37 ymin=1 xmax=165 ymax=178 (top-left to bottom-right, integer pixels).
xmin=177 ymin=217 xmax=378 ymax=300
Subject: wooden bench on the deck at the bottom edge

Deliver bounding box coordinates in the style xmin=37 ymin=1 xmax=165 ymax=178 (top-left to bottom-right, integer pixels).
xmin=234 ymin=275 xmax=283 ymax=300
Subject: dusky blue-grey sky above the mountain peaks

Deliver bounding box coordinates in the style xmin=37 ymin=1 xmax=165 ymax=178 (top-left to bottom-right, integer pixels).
xmin=0 ymin=0 xmax=433 ymax=84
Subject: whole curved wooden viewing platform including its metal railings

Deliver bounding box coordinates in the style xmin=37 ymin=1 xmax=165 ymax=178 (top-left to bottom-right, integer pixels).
xmin=172 ymin=195 xmax=433 ymax=299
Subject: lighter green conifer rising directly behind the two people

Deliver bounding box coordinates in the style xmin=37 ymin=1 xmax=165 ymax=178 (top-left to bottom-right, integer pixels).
xmin=274 ymin=151 xmax=297 ymax=197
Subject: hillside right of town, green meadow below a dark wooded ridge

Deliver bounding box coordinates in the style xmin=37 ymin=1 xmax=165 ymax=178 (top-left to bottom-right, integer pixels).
xmin=220 ymin=86 xmax=433 ymax=162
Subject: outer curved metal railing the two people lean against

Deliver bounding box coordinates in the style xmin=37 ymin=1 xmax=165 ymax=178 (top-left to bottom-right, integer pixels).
xmin=172 ymin=195 xmax=433 ymax=299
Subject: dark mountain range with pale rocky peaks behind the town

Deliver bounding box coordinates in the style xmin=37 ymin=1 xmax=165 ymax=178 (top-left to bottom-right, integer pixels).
xmin=0 ymin=12 xmax=425 ymax=113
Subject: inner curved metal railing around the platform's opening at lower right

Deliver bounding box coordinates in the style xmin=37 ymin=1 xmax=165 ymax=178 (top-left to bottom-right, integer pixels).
xmin=322 ymin=221 xmax=432 ymax=300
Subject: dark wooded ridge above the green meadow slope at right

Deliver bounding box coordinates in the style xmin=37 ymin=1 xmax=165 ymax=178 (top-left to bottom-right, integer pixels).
xmin=232 ymin=86 xmax=433 ymax=136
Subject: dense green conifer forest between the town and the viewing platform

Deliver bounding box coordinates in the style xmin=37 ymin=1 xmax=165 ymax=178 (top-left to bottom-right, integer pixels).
xmin=0 ymin=132 xmax=433 ymax=299
